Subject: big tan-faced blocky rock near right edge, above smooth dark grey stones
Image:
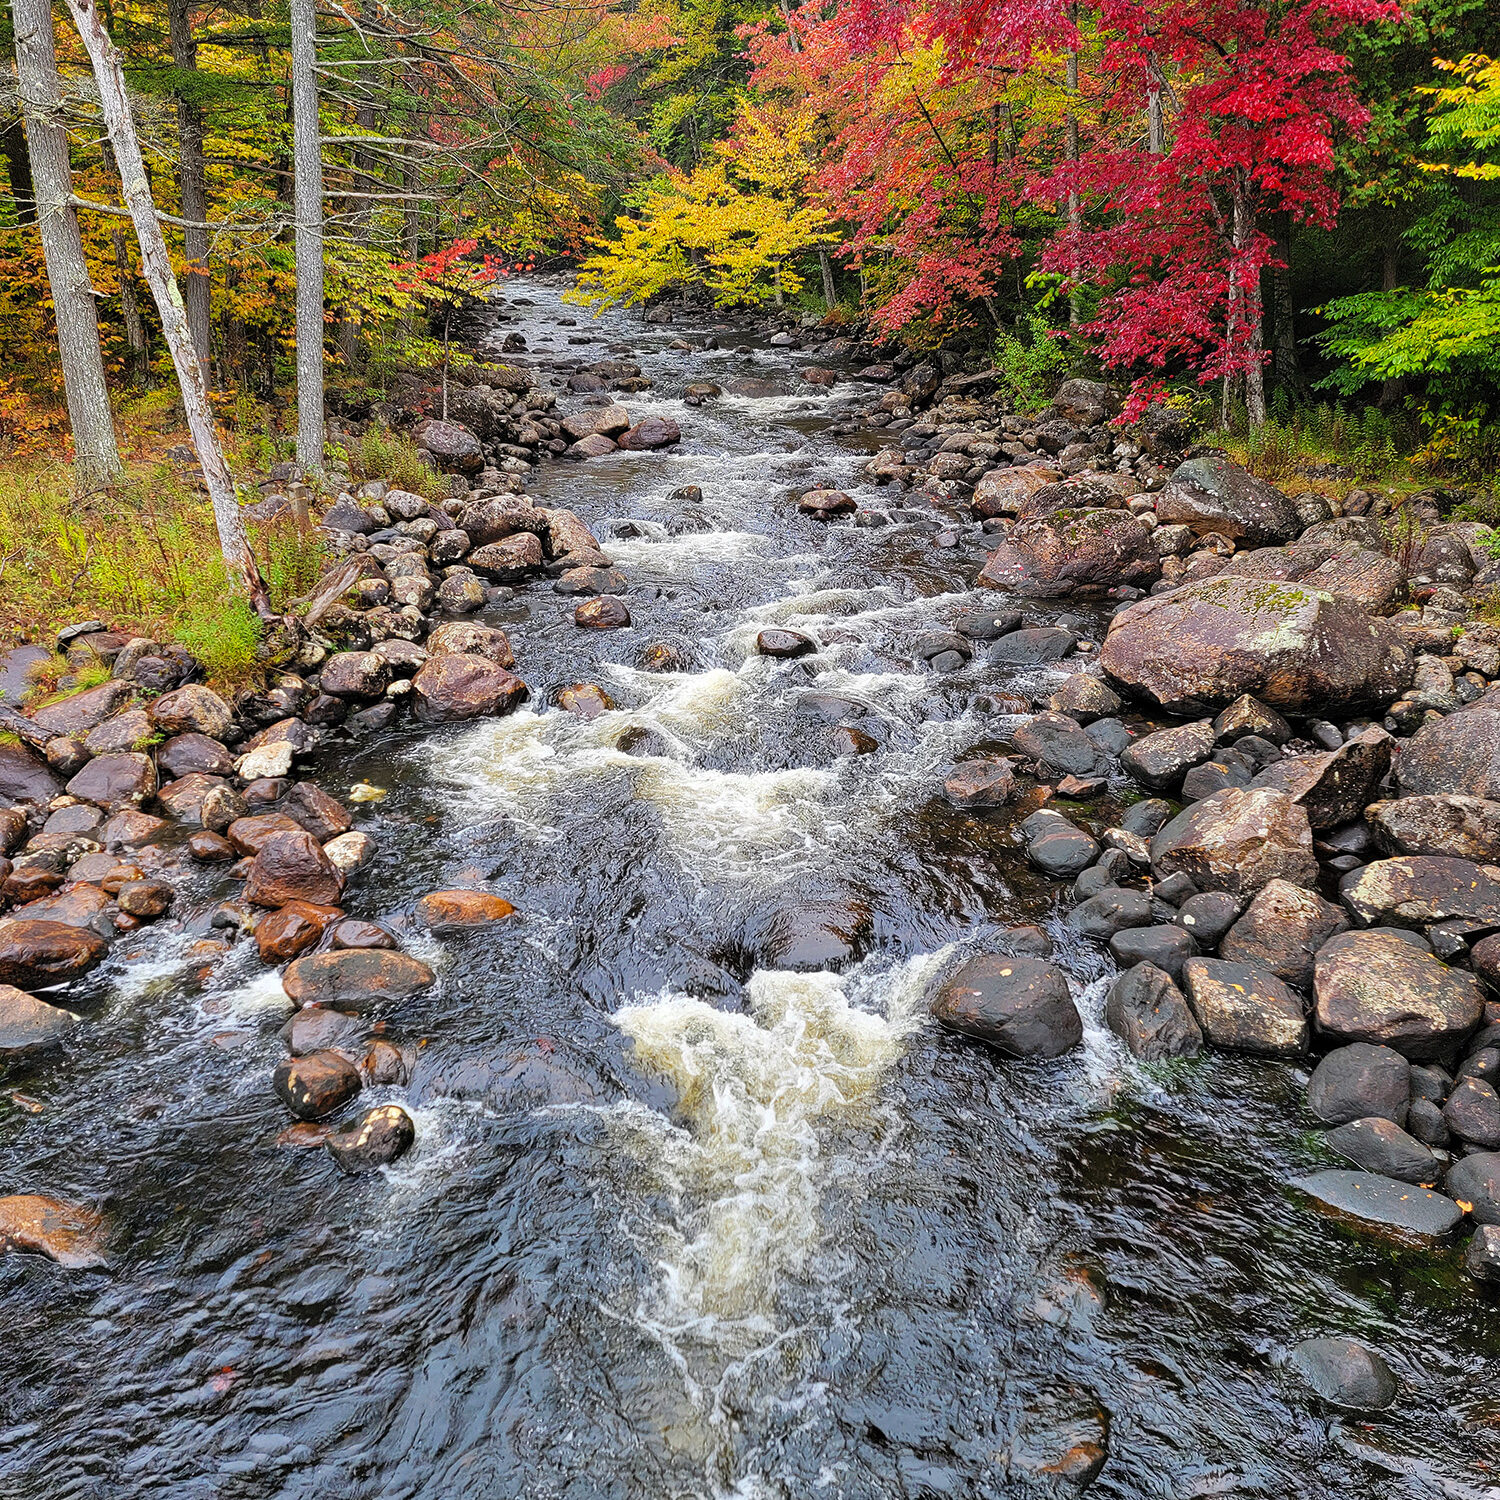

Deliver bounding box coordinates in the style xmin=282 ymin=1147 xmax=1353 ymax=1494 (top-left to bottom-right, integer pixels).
xmin=1313 ymin=932 xmax=1484 ymax=1059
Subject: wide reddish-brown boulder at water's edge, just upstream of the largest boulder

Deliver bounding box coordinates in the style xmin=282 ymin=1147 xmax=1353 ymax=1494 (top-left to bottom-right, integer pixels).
xmin=980 ymin=510 xmax=1161 ymax=599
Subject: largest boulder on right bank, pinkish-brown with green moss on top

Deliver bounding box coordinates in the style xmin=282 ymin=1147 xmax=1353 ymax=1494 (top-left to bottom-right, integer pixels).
xmin=1100 ymin=578 xmax=1415 ymax=716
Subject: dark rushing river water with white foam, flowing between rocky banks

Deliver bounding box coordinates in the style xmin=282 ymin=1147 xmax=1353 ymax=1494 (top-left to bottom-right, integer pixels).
xmin=0 ymin=285 xmax=1500 ymax=1500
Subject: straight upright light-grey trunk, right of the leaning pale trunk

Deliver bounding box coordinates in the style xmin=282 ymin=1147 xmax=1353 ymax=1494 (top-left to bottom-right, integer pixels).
xmin=289 ymin=0 xmax=324 ymax=474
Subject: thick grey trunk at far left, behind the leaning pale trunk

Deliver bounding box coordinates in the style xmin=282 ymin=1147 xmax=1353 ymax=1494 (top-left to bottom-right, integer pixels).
xmin=12 ymin=0 xmax=125 ymax=489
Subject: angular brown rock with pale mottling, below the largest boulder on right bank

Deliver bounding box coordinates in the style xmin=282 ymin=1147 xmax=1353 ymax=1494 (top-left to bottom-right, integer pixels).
xmin=1151 ymin=786 xmax=1319 ymax=896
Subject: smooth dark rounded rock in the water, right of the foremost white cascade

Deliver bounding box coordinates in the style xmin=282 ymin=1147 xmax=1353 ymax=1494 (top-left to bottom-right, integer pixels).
xmin=932 ymin=954 xmax=1083 ymax=1058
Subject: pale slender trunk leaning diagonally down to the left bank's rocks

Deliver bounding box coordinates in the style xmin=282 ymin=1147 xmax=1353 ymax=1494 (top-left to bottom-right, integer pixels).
xmin=68 ymin=0 xmax=270 ymax=615
